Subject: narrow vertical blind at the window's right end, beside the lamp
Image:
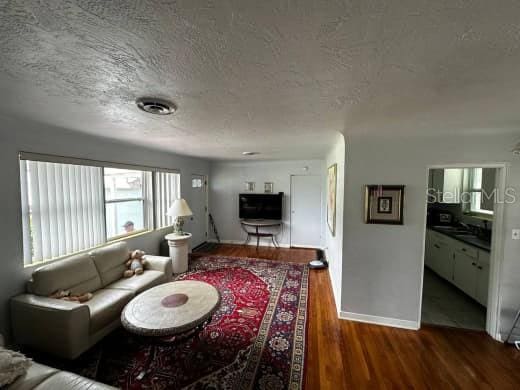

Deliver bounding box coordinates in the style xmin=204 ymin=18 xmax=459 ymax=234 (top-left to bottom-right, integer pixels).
xmin=155 ymin=172 xmax=180 ymax=228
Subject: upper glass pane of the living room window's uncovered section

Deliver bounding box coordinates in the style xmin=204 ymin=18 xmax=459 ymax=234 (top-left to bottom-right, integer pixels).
xmin=104 ymin=168 xmax=144 ymax=200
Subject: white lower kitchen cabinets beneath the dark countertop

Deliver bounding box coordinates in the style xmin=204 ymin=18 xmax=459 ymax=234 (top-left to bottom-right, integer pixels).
xmin=424 ymin=229 xmax=490 ymax=306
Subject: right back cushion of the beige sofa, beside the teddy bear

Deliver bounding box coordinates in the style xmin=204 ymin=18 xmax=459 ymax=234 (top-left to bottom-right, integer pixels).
xmin=90 ymin=242 xmax=129 ymax=287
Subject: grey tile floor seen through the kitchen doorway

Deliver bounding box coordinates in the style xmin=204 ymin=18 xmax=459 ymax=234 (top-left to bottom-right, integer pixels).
xmin=422 ymin=267 xmax=486 ymax=330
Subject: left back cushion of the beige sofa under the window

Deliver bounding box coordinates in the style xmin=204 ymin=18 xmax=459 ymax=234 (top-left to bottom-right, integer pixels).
xmin=29 ymin=253 xmax=101 ymax=296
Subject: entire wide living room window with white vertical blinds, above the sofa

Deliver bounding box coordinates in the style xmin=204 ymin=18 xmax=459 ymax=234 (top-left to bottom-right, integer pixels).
xmin=20 ymin=153 xmax=180 ymax=265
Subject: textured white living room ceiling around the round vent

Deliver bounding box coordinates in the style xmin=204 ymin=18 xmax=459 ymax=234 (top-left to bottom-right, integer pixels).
xmin=0 ymin=0 xmax=520 ymax=159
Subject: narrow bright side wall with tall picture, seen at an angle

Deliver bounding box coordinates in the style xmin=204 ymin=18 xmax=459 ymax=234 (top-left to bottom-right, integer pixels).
xmin=323 ymin=134 xmax=345 ymax=310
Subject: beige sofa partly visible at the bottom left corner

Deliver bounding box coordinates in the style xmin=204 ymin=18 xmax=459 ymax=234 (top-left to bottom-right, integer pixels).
xmin=6 ymin=363 xmax=116 ymax=390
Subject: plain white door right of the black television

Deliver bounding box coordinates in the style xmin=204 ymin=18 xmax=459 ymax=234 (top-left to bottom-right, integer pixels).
xmin=291 ymin=175 xmax=322 ymax=248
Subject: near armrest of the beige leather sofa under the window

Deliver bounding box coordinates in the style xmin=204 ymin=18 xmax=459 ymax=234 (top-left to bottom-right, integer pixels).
xmin=11 ymin=294 xmax=90 ymax=359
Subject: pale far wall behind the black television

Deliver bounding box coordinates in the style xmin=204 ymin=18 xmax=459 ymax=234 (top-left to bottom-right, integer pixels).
xmin=209 ymin=160 xmax=325 ymax=245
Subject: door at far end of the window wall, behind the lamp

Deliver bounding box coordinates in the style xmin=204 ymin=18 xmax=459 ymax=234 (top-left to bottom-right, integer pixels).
xmin=188 ymin=175 xmax=208 ymax=248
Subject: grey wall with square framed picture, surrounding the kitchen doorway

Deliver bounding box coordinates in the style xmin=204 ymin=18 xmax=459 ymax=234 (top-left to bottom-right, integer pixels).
xmin=342 ymin=135 xmax=520 ymax=331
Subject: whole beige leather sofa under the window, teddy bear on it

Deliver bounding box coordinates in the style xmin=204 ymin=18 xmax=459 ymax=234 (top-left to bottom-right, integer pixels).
xmin=11 ymin=242 xmax=172 ymax=359
